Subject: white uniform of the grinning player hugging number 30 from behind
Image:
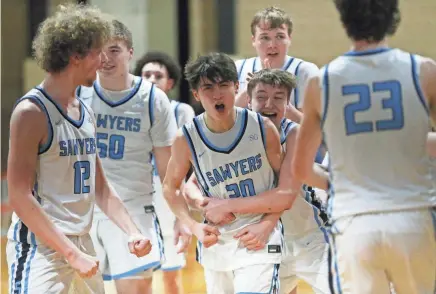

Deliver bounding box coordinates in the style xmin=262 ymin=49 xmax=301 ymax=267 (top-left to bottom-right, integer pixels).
xmin=280 ymin=119 xmax=330 ymax=294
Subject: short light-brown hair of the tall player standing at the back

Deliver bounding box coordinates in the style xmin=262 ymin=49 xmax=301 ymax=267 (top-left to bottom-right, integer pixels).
xmin=250 ymin=6 xmax=293 ymax=36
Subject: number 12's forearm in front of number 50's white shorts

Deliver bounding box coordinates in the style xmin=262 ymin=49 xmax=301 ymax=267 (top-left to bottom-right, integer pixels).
xmin=95 ymin=183 xmax=141 ymax=236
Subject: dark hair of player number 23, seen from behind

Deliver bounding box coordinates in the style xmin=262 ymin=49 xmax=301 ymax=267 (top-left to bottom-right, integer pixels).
xmin=334 ymin=0 xmax=401 ymax=42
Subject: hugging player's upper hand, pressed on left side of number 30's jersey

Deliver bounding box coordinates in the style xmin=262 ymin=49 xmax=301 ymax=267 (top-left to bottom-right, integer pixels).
xmin=201 ymin=198 xmax=236 ymax=226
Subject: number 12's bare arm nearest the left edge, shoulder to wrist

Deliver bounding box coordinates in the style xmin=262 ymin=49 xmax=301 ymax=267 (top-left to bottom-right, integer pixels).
xmin=7 ymin=100 xmax=79 ymax=261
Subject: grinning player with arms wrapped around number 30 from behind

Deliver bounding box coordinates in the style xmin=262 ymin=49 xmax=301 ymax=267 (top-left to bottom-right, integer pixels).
xmin=203 ymin=69 xmax=330 ymax=294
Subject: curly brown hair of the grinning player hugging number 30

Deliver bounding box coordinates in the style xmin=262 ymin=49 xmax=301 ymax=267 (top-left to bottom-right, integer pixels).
xmin=247 ymin=68 xmax=297 ymax=100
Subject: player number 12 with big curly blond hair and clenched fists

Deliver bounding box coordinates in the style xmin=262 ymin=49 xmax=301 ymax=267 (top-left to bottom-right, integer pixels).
xmin=6 ymin=5 xmax=151 ymax=293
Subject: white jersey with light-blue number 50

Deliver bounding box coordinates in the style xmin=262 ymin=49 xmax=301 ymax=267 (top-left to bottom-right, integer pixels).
xmin=78 ymin=77 xmax=176 ymax=218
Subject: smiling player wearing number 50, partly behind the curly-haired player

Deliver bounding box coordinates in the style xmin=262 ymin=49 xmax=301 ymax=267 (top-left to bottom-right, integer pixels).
xmin=77 ymin=20 xmax=181 ymax=294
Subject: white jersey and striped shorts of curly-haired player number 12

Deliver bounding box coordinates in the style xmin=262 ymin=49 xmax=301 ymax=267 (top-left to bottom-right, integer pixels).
xmin=6 ymin=86 xmax=104 ymax=294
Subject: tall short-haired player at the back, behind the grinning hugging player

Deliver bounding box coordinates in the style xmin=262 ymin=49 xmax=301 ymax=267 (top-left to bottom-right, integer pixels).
xmin=236 ymin=6 xmax=318 ymax=122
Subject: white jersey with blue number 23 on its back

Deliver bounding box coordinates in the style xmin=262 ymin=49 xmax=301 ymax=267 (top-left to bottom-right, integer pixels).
xmin=320 ymin=48 xmax=436 ymax=220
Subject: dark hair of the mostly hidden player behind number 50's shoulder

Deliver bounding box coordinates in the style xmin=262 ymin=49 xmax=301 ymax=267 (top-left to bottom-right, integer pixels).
xmin=133 ymin=51 xmax=182 ymax=85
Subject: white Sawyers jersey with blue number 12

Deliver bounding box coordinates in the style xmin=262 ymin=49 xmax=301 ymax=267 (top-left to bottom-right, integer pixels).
xmin=8 ymin=86 xmax=96 ymax=244
